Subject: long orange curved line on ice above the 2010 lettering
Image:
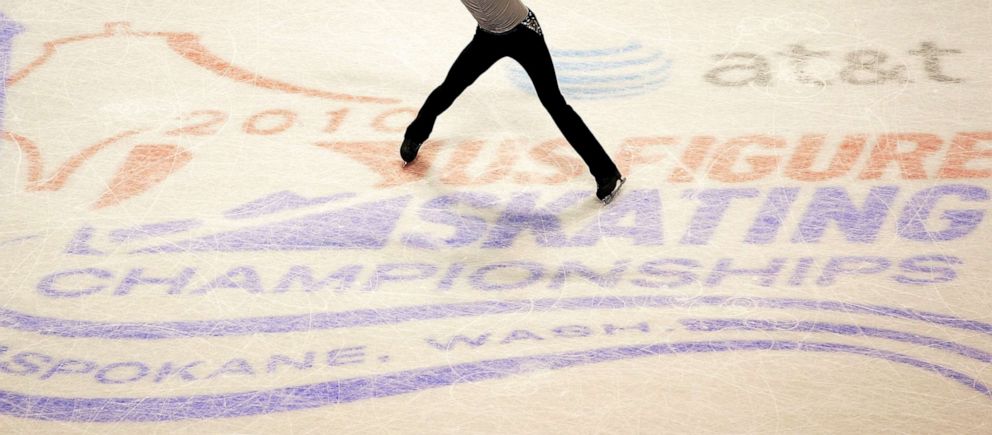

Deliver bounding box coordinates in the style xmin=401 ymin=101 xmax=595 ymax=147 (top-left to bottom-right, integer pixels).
xmin=6 ymin=22 xmax=400 ymax=104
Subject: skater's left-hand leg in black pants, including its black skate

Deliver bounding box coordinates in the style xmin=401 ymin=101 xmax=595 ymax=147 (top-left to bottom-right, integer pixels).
xmin=400 ymin=29 xmax=504 ymax=163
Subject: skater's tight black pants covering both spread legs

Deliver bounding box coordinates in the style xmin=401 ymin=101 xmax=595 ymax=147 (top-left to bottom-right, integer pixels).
xmin=405 ymin=24 xmax=619 ymax=180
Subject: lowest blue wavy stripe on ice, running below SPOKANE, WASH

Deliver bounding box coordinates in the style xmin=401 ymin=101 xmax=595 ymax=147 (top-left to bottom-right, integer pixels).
xmin=0 ymin=340 xmax=992 ymax=423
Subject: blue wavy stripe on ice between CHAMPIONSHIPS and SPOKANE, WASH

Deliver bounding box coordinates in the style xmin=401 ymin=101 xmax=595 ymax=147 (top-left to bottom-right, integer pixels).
xmin=0 ymin=295 xmax=992 ymax=340
